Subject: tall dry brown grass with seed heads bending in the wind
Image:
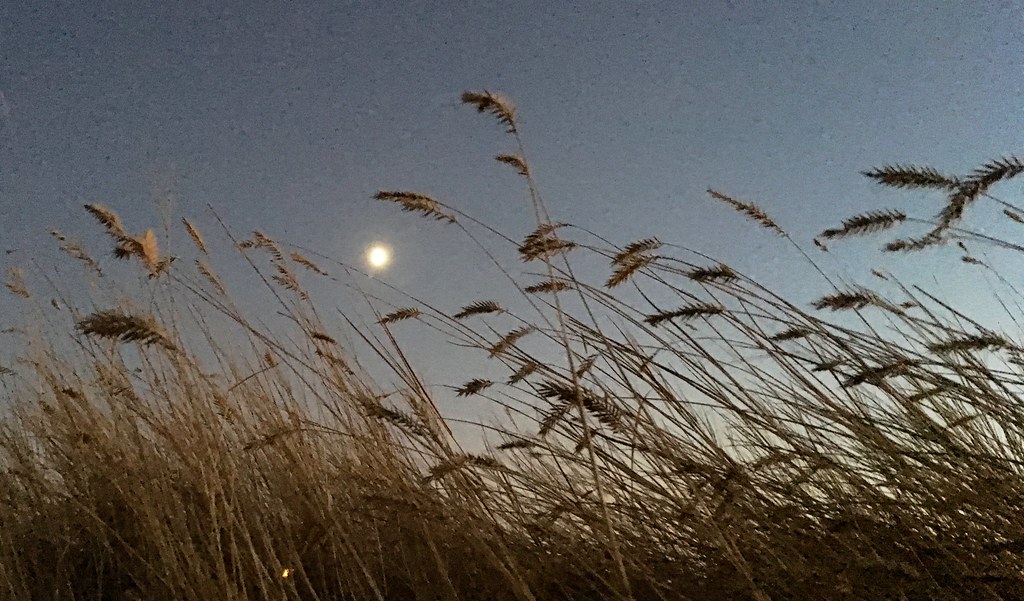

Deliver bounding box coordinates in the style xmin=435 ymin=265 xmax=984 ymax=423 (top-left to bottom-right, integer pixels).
xmin=0 ymin=92 xmax=1024 ymax=601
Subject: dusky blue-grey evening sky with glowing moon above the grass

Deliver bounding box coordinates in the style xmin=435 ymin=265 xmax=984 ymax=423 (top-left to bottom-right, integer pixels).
xmin=0 ymin=0 xmax=1024 ymax=423
